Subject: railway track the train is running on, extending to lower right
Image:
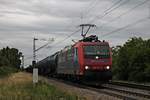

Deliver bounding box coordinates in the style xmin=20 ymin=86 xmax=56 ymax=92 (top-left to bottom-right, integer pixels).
xmin=47 ymin=78 xmax=150 ymax=100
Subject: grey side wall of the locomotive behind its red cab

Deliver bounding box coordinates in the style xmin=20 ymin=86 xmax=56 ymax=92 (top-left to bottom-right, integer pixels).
xmin=57 ymin=47 xmax=79 ymax=75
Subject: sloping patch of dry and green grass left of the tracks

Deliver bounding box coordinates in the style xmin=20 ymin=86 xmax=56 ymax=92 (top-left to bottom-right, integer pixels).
xmin=0 ymin=72 xmax=81 ymax=100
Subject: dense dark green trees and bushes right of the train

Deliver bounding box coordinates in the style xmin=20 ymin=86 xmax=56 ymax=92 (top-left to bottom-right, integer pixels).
xmin=112 ymin=37 xmax=150 ymax=82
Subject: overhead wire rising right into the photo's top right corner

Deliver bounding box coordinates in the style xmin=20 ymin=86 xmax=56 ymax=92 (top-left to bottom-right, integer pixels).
xmin=99 ymin=0 xmax=150 ymax=28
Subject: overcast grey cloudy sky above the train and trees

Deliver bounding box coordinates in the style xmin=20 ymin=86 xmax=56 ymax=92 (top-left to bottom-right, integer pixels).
xmin=0 ymin=0 xmax=150 ymax=65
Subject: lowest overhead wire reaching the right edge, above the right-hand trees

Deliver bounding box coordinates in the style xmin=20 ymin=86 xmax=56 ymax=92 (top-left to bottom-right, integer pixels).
xmin=102 ymin=17 xmax=149 ymax=37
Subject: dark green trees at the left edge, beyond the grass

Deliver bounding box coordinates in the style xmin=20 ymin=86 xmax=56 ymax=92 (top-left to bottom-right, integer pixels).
xmin=0 ymin=47 xmax=22 ymax=77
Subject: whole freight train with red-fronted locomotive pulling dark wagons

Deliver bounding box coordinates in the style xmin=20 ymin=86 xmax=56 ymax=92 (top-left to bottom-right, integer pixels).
xmin=26 ymin=35 xmax=112 ymax=82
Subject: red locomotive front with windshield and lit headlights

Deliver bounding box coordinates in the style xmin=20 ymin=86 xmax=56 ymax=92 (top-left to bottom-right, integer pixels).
xmin=82 ymin=42 xmax=112 ymax=81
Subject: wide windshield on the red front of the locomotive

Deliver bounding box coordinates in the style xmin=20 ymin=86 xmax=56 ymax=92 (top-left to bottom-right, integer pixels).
xmin=84 ymin=45 xmax=110 ymax=58
